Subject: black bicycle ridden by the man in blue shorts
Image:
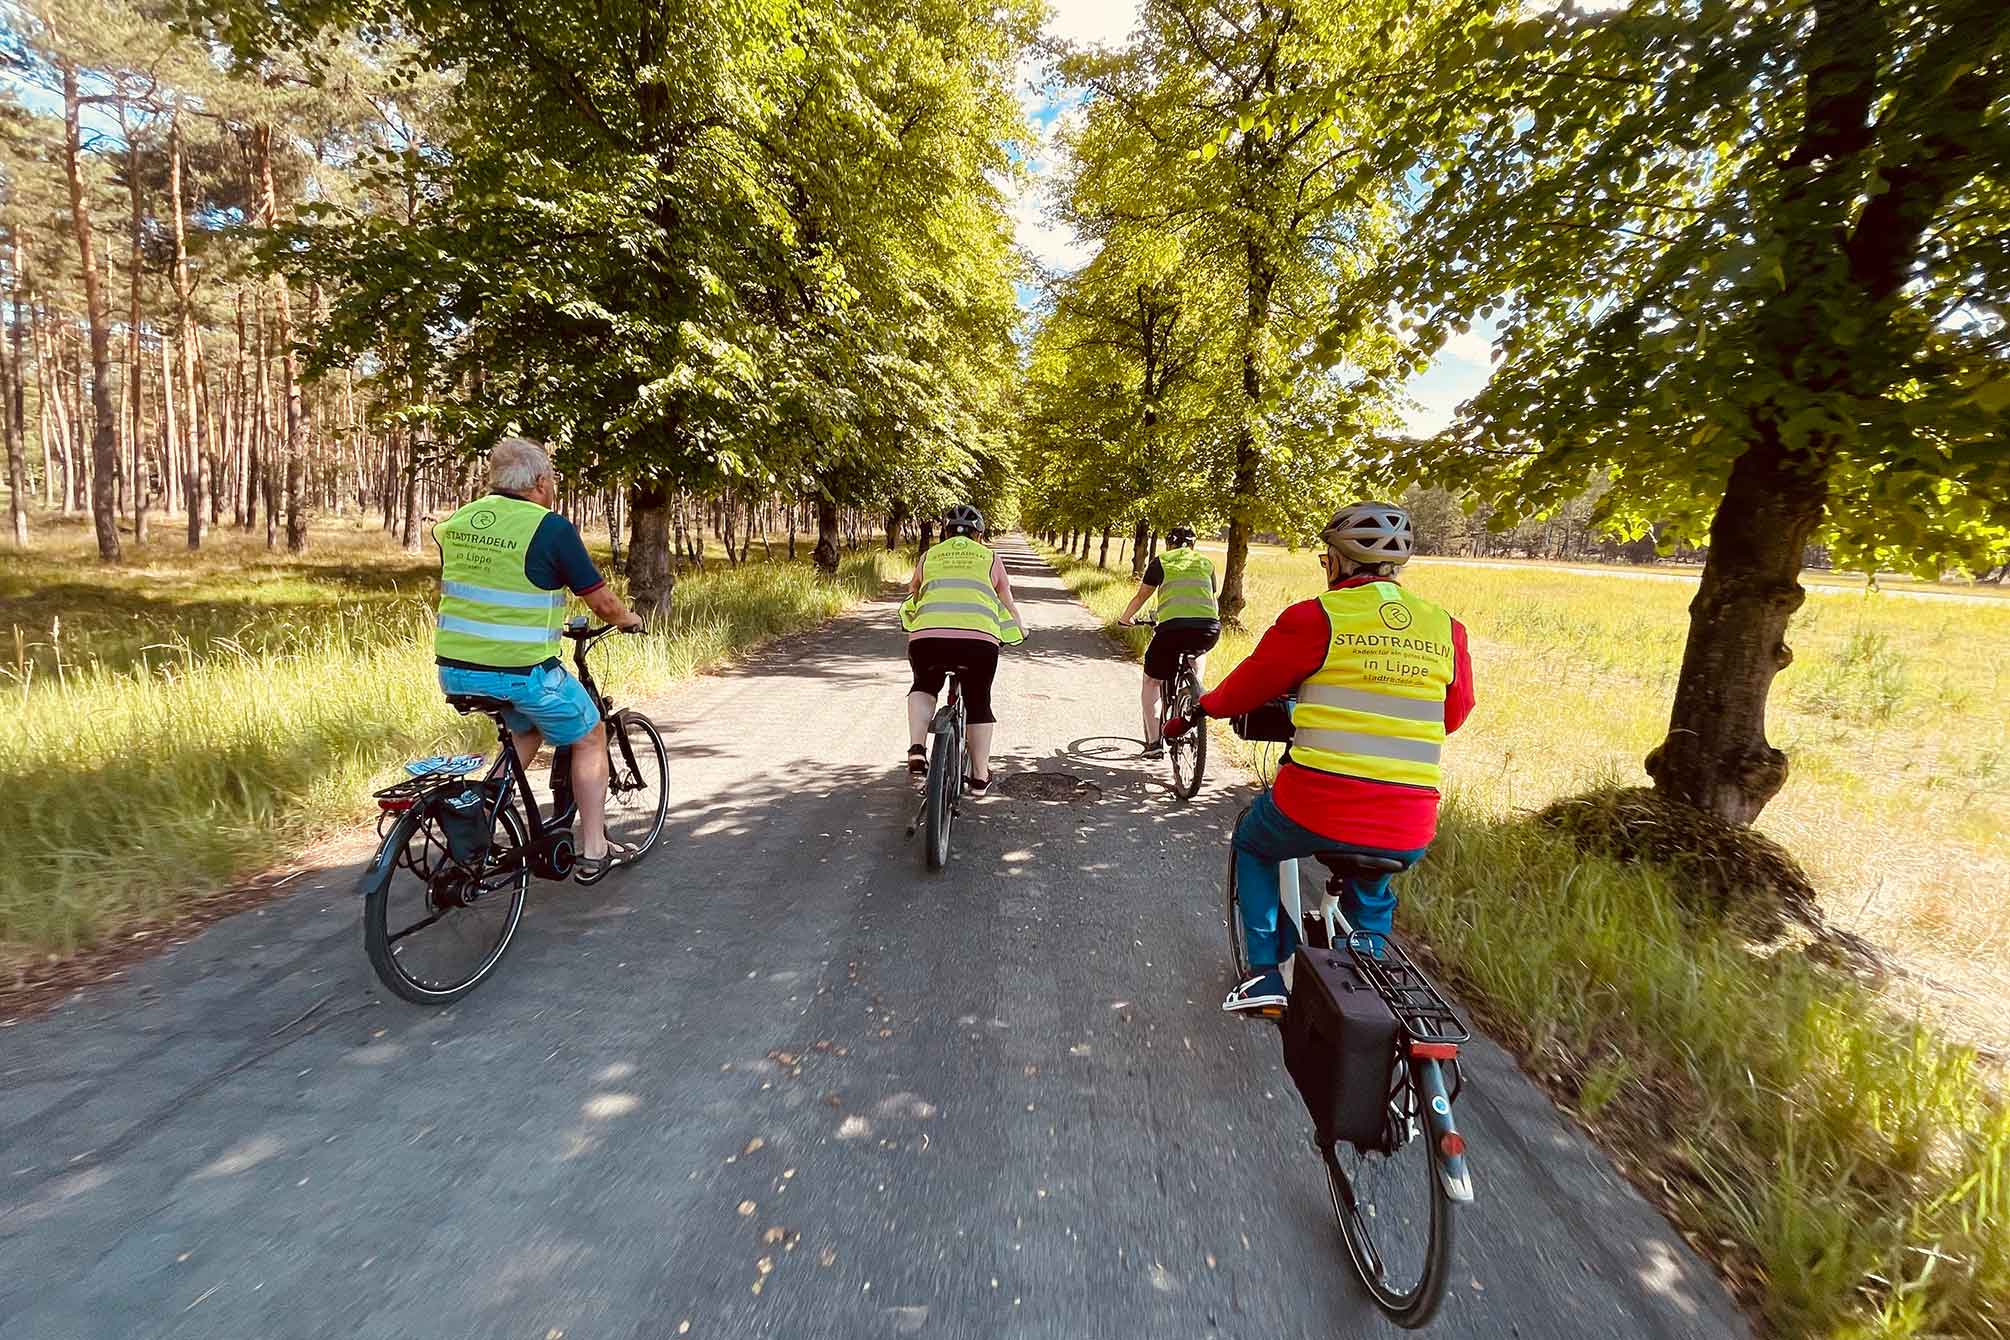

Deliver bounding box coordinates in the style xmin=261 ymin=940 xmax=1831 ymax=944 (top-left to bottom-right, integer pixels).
xmin=360 ymin=619 xmax=669 ymax=1004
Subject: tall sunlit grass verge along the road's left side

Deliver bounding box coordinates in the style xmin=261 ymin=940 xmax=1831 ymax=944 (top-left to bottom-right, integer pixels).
xmin=0 ymin=552 xmax=907 ymax=964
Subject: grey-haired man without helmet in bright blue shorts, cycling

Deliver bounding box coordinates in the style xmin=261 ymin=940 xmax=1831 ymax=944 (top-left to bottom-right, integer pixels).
xmin=432 ymin=438 xmax=641 ymax=884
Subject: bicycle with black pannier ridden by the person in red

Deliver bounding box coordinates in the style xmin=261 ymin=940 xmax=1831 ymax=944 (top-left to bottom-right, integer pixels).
xmin=1226 ymin=719 xmax=1473 ymax=1330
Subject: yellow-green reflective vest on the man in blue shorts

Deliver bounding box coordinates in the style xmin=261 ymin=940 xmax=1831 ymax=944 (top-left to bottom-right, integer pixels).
xmin=432 ymin=494 xmax=565 ymax=669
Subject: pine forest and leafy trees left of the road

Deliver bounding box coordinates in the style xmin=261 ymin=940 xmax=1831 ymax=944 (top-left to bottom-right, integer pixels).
xmin=0 ymin=0 xmax=1033 ymax=609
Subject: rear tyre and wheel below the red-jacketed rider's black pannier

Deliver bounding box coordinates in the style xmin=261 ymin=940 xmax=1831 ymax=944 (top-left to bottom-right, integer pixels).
xmin=1321 ymin=1073 xmax=1453 ymax=1330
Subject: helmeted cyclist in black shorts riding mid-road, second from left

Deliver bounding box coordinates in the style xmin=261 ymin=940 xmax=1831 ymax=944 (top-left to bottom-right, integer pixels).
xmin=900 ymin=502 xmax=1025 ymax=796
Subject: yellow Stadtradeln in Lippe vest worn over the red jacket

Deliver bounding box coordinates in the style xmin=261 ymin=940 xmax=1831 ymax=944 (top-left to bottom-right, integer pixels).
xmin=1290 ymin=581 xmax=1455 ymax=790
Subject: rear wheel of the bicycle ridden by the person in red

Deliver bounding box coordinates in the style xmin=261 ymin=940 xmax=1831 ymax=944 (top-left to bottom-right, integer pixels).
xmin=1323 ymin=1065 xmax=1453 ymax=1330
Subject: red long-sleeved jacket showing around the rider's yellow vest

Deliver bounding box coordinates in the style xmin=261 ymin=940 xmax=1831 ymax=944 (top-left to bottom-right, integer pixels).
xmin=1200 ymin=577 xmax=1473 ymax=852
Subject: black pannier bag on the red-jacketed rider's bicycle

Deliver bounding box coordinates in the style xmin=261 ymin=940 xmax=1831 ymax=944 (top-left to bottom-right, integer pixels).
xmin=1284 ymin=948 xmax=1397 ymax=1151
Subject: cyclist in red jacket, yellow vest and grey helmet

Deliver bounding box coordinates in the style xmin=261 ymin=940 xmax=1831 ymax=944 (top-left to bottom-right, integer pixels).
xmin=1166 ymin=502 xmax=1473 ymax=1013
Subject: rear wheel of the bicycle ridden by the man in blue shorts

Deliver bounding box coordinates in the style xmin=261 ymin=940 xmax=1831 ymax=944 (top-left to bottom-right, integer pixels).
xmin=364 ymin=800 xmax=531 ymax=1004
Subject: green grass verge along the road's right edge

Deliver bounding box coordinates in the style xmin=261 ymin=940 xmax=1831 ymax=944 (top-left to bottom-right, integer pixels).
xmin=1047 ymin=552 xmax=2010 ymax=1340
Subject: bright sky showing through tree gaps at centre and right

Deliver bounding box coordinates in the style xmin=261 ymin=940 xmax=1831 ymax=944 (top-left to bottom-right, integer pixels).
xmin=1013 ymin=0 xmax=1491 ymax=434
